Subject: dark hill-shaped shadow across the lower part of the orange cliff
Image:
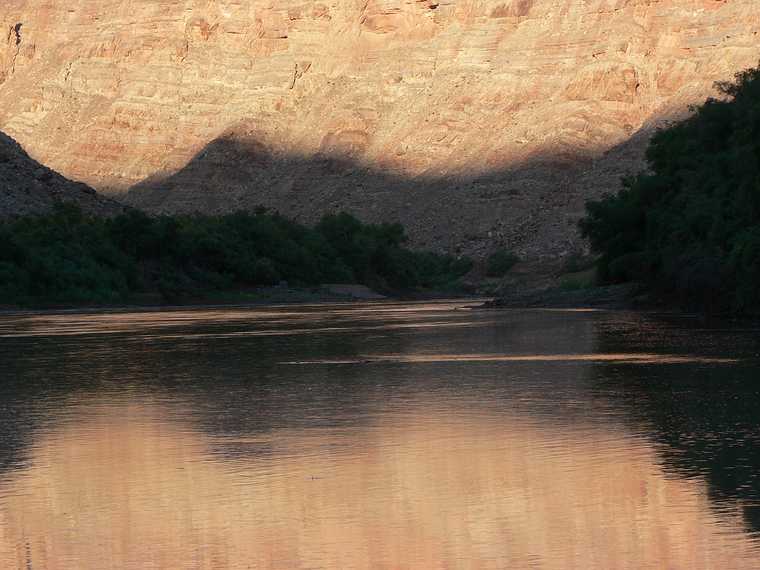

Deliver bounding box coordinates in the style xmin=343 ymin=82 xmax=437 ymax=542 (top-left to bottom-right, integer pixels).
xmin=121 ymin=130 xmax=651 ymax=260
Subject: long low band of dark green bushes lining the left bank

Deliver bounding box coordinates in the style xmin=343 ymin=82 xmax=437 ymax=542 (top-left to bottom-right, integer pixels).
xmin=0 ymin=203 xmax=471 ymax=305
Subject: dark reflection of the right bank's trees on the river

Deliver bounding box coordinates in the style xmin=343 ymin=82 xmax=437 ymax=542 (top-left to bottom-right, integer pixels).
xmin=596 ymin=318 xmax=760 ymax=533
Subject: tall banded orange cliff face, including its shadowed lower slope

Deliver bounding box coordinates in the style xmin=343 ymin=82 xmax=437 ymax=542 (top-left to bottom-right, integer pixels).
xmin=0 ymin=0 xmax=760 ymax=256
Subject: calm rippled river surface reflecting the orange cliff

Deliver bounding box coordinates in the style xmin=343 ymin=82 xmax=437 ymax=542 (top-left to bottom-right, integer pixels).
xmin=0 ymin=302 xmax=760 ymax=570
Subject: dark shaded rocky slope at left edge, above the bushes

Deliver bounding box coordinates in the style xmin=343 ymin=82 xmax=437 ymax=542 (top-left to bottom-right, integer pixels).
xmin=0 ymin=132 xmax=123 ymax=218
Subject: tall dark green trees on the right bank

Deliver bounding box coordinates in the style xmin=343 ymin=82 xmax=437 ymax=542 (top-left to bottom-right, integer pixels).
xmin=581 ymin=68 xmax=760 ymax=314
